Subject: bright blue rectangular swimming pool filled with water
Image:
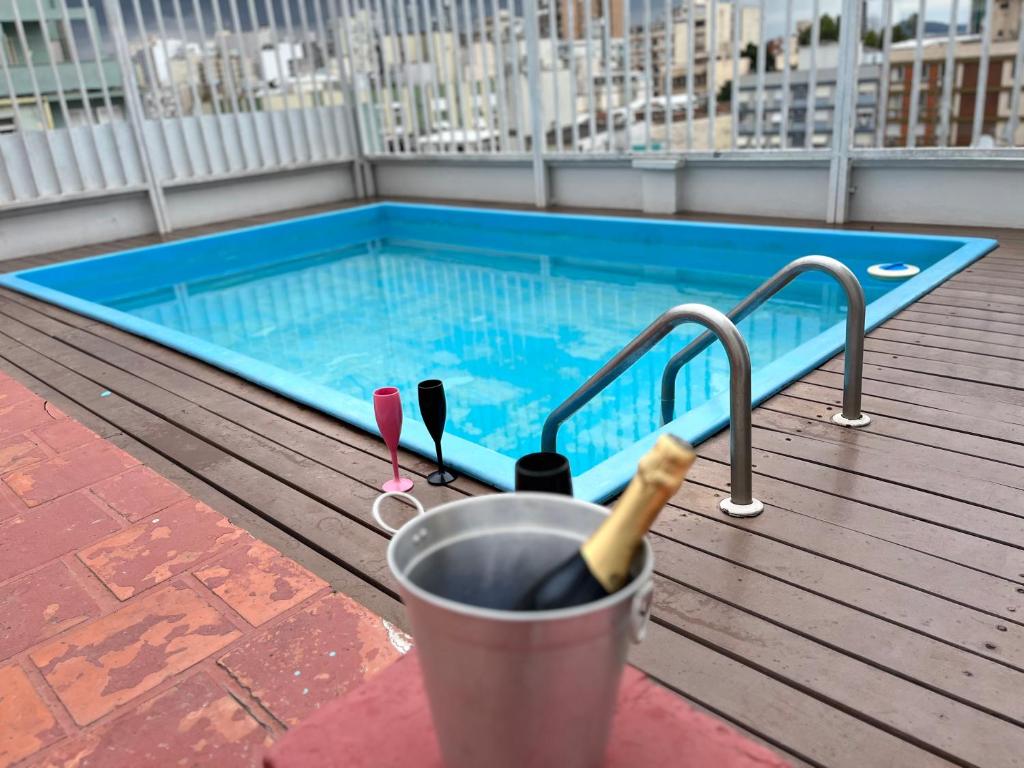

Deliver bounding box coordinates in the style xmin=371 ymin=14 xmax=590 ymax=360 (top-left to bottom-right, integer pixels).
xmin=0 ymin=203 xmax=996 ymax=500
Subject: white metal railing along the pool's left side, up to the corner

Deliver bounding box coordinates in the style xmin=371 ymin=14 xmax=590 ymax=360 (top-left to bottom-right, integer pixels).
xmin=0 ymin=0 xmax=357 ymax=231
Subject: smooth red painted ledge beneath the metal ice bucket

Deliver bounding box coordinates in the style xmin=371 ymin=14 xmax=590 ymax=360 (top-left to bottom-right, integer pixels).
xmin=263 ymin=650 xmax=786 ymax=768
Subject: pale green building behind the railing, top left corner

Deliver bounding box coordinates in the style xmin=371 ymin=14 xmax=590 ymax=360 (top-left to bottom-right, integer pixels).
xmin=0 ymin=0 xmax=124 ymax=133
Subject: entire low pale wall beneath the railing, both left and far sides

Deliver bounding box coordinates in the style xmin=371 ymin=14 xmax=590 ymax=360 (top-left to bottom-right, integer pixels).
xmin=0 ymin=155 xmax=1024 ymax=259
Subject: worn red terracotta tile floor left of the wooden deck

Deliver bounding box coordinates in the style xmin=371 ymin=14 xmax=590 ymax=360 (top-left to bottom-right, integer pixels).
xmin=0 ymin=374 xmax=408 ymax=768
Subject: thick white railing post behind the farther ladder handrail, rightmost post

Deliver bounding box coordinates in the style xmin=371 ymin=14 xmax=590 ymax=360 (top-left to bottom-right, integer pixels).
xmin=825 ymin=0 xmax=860 ymax=224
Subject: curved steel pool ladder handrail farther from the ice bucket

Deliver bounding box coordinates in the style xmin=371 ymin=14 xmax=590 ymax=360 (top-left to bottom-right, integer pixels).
xmin=662 ymin=256 xmax=870 ymax=427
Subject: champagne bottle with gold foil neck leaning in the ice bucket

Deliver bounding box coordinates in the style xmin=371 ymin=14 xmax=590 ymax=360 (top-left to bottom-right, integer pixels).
xmin=516 ymin=435 xmax=694 ymax=610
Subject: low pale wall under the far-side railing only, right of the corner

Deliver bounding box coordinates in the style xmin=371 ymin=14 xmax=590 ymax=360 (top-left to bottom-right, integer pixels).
xmin=374 ymin=152 xmax=1024 ymax=227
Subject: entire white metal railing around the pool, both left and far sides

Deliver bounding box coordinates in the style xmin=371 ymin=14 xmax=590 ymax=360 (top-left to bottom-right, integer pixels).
xmin=0 ymin=0 xmax=1024 ymax=229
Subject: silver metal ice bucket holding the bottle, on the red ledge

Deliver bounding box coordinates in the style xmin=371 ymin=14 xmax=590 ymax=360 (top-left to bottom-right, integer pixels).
xmin=378 ymin=494 xmax=653 ymax=768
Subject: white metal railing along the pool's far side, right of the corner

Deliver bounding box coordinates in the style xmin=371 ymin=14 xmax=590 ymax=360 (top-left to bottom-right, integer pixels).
xmin=351 ymin=0 xmax=1024 ymax=155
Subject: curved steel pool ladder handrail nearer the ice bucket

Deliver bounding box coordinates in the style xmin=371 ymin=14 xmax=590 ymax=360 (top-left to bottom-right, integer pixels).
xmin=541 ymin=304 xmax=764 ymax=517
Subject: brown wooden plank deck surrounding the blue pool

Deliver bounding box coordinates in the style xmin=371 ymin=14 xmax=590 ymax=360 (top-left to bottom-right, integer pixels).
xmin=0 ymin=204 xmax=1024 ymax=768
